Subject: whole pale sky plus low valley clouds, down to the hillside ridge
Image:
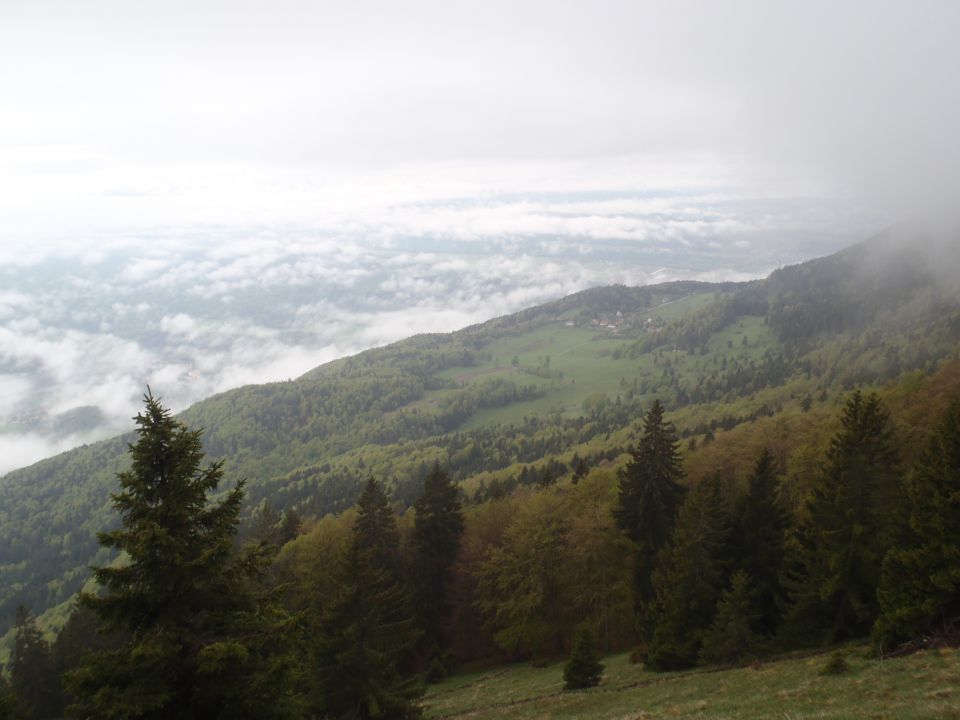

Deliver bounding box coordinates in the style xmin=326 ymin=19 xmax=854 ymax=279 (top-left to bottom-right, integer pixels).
xmin=0 ymin=0 xmax=960 ymax=472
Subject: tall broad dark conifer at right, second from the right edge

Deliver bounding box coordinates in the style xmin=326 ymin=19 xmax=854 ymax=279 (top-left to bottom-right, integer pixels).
xmin=784 ymin=391 xmax=903 ymax=643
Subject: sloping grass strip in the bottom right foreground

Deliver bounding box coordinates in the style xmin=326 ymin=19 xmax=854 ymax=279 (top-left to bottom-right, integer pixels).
xmin=424 ymin=648 xmax=960 ymax=720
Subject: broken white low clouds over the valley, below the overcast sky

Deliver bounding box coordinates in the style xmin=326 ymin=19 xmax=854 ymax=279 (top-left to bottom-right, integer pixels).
xmin=0 ymin=188 xmax=866 ymax=471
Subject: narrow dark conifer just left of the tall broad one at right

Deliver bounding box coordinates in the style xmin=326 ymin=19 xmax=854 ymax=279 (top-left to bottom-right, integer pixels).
xmin=731 ymin=449 xmax=787 ymax=636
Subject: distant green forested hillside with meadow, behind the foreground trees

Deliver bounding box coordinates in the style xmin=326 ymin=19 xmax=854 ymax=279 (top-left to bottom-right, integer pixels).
xmin=0 ymin=225 xmax=960 ymax=660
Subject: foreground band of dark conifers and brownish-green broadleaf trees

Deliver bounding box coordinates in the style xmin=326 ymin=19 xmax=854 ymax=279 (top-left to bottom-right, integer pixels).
xmin=0 ymin=392 xmax=960 ymax=720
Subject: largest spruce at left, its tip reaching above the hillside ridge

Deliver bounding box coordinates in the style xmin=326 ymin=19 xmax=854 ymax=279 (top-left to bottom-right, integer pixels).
xmin=68 ymin=393 xmax=286 ymax=720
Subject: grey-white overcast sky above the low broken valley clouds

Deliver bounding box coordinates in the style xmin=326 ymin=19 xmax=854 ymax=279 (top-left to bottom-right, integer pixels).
xmin=0 ymin=0 xmax=960 ymax=247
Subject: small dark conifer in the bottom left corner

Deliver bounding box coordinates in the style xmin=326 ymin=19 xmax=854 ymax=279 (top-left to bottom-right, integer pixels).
xmin=10 ymin=606 xmax=62 ymax=720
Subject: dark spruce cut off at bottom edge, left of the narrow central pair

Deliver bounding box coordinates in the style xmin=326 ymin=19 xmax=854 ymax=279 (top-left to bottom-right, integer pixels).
xmin=313 ymin=478 xmax=422 ymax=720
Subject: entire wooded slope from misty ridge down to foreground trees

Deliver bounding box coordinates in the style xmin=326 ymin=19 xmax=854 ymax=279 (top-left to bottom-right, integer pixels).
xmin=0 ymin=224 xmax=960 ymax=718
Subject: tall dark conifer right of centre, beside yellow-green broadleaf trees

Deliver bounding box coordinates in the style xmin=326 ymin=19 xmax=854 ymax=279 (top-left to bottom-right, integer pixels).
xmin=614 ymin=400 xmax=684 ymax=615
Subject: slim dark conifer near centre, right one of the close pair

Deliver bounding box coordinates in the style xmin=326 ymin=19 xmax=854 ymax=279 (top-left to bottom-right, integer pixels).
xmin=413 ymin=463 xmax=463 ymax=654
